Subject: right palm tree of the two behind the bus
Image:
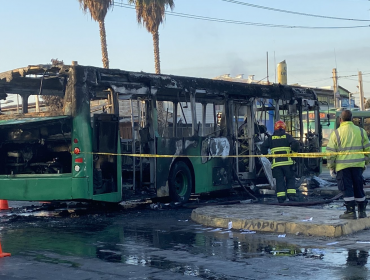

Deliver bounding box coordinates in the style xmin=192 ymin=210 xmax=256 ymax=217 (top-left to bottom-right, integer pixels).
xmin=128 ymin=0 xmax=175 ymax=74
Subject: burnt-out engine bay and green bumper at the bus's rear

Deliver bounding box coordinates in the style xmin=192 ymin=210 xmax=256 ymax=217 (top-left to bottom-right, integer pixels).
xmin=0 ymin=116 xmax=73 ymax=200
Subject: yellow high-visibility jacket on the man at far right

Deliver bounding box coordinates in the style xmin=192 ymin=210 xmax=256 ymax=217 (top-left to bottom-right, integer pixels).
xmin=326 ymin=121 xmax=370 ymax=172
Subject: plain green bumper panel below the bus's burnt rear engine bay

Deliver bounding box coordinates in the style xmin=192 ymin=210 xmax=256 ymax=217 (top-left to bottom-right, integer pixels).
xmin=0 ymin=174 xmax=73 ymax=201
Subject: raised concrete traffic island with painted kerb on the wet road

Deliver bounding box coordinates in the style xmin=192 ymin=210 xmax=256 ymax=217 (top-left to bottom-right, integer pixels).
xmin=191 ymin=204 xmax=370 ymax=237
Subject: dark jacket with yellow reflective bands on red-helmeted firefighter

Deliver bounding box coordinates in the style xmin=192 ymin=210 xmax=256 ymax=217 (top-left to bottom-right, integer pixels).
xmin=261 ymin=129 xmax=297 ymax=168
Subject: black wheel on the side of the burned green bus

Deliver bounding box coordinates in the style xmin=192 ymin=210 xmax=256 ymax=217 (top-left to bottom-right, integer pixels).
xmin=168 ymin=161 xmax=193 ymax=202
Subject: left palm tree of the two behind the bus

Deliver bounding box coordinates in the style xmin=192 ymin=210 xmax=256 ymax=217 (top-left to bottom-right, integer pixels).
xmin=78 ymin=0 xmax=114 ymax=68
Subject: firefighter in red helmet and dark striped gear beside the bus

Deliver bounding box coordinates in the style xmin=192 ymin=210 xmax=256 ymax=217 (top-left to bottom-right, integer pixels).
xmin=261 ymin=120 xmax=299 ymax=203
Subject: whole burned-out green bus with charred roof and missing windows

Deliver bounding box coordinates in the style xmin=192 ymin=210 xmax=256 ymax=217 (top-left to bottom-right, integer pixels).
xmin=0 ymin=64 xmax=321 ymax=202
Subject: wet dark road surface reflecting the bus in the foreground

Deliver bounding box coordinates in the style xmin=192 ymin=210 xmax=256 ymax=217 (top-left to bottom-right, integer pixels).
xmin=0 ymin=208 xmax=370 ymax=280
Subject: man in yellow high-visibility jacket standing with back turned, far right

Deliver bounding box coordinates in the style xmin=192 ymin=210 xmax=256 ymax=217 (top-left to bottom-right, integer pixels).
xmin=326 ymin=110 xmax=370 ymax=219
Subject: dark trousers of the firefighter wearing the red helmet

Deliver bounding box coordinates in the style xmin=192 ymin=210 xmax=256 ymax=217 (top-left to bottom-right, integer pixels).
xmin=272 ymin=165 xmax=296 ymax=198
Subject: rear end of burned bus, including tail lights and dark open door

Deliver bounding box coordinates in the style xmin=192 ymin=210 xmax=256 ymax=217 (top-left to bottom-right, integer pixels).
xmin=0 ymin=64 xmax=122 ymax=202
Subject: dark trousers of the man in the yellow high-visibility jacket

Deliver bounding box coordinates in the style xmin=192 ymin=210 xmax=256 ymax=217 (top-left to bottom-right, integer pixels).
xmin=337 ymin=167 xmax=365 ymax=201
